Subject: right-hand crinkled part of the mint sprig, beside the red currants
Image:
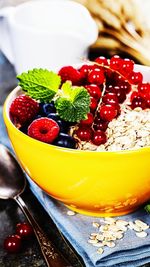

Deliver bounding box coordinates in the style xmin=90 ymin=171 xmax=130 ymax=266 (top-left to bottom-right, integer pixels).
xmin=55 ymin=82 xmax=90 ymax=122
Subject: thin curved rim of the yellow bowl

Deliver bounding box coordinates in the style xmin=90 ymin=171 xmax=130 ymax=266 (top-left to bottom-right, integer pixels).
xmin=3 ymin=64 xmax=150 ymax=155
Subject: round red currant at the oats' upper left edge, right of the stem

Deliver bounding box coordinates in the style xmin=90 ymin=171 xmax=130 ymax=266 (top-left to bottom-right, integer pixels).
xmin=100 ymin=105 xmax=117 ymax=121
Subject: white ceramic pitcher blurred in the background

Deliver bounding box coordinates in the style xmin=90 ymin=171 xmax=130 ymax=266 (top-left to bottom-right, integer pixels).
xmin=0 ymin=0 xmax=98 ymax=73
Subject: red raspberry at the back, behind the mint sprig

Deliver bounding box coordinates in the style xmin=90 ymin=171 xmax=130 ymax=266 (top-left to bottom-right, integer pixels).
xmin=58 ymin=66 xmax=82 ymax=85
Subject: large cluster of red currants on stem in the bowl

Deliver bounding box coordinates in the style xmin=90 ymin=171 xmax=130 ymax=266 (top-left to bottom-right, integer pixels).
xmin=72 ymin=55 xmax=150 ymax=146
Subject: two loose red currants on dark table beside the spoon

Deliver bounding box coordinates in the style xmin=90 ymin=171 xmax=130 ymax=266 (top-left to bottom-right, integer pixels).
xmin=4 ymin=223 xmax=33 ymax=253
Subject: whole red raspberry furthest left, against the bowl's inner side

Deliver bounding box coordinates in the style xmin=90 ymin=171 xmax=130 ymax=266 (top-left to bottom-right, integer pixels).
xmin=10 ymin=95 xmax=39 ymax=126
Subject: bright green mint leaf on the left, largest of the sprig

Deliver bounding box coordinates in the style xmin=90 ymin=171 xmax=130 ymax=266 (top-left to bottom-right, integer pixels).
xmin=17 ymin=69 xmax=61 ymax=102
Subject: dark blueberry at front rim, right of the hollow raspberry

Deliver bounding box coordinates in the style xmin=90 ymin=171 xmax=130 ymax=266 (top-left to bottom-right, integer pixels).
xmin=53 ymin=133 xmax=76 ymax=149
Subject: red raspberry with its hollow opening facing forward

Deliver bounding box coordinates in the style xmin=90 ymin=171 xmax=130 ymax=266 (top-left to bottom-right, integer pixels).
xmin=28 ymin=117 xmax=60 ymax=144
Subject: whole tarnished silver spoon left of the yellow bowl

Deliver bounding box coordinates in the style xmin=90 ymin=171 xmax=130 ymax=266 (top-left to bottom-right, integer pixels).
xmin=0 ymin=144 xmax=71 ymax=267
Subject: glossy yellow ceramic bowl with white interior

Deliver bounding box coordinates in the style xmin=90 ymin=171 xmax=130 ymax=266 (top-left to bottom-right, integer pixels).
xmin=4 ymin=66 xmax=150 ymax=216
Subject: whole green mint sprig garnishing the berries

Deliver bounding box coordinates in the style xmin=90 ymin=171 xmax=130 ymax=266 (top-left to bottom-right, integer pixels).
xmin=17 ymin=69 xmax=90 ymax=122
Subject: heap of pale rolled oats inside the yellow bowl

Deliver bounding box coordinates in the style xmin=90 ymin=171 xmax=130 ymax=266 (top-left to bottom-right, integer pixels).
xmin=79 ymin=107 xmax=150 ymax=151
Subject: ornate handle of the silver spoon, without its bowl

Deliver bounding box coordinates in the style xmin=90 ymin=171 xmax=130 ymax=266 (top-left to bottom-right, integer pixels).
xmin=14 ymin=196 xmax=71 ymax=267
